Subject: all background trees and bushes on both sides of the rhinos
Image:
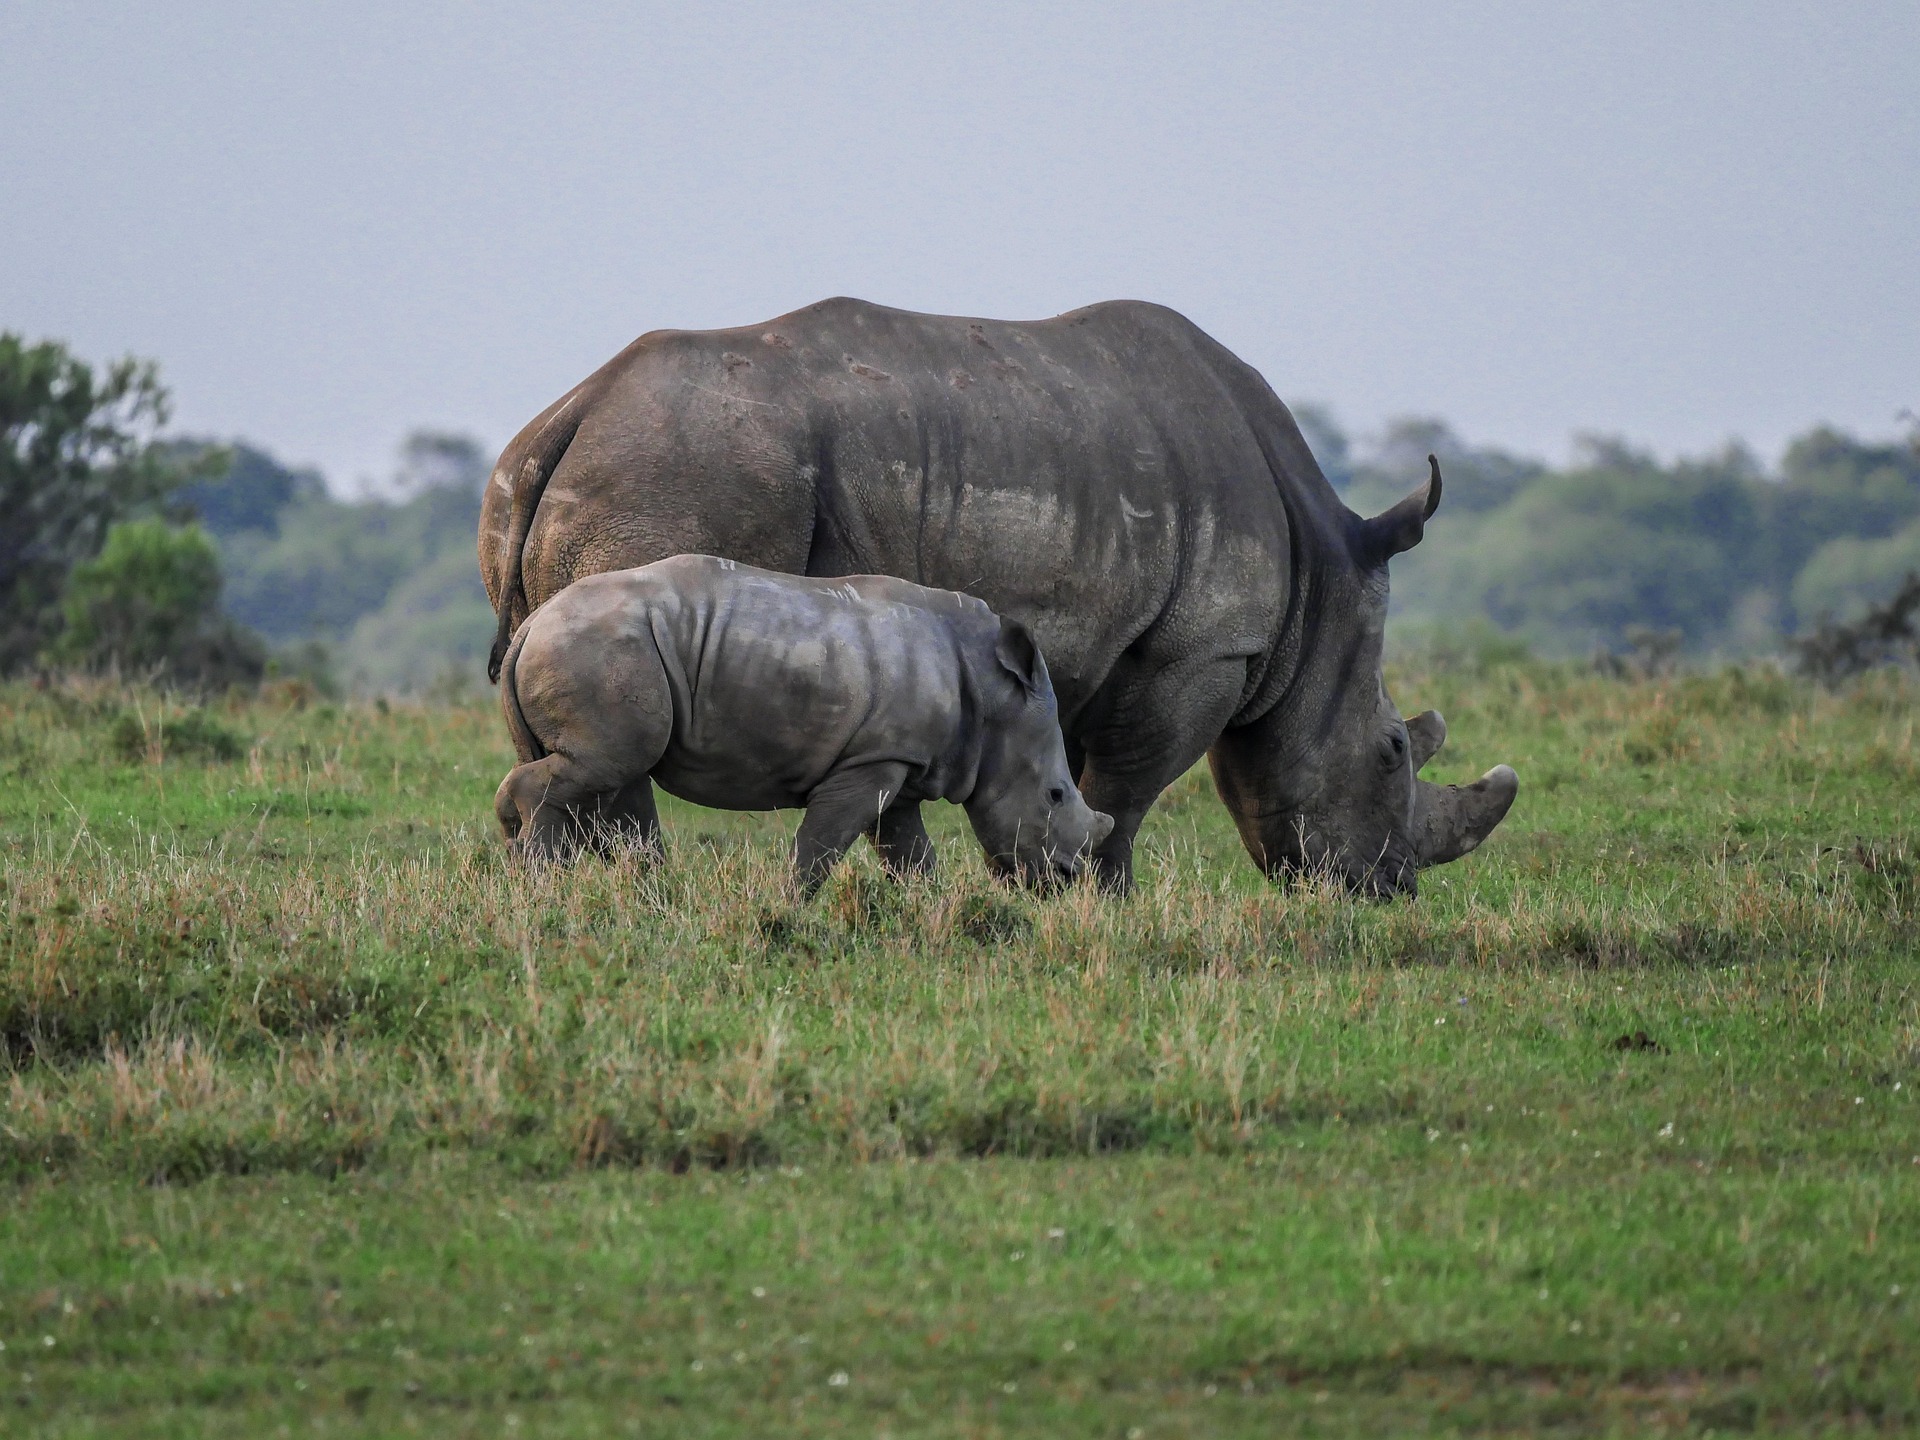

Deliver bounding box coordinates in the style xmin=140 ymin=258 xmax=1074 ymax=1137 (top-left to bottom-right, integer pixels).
xmin=0 ymin=334 xmax=1920 ymax=695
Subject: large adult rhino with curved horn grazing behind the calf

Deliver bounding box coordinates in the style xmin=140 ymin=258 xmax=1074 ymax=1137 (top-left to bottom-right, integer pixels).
xmin=480 ymin=300 xmax=1519 ymax=895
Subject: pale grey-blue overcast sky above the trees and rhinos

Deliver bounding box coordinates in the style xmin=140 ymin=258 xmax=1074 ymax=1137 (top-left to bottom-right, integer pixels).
xmin=0 ymin=0 xmax=1920 ymax=488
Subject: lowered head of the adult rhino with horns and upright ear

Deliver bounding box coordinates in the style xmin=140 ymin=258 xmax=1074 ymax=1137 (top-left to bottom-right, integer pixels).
xmin=1208 ymin=455 xmax=1521 ymax=897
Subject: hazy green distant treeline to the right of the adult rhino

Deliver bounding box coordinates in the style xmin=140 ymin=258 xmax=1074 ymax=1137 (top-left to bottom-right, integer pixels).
xmin=1296 ymin=407 xmax=1920 ymax=655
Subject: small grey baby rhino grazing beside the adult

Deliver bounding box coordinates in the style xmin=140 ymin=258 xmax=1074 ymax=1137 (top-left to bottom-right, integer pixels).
xmin=493 ymin=555 xmax=1114 ymax=893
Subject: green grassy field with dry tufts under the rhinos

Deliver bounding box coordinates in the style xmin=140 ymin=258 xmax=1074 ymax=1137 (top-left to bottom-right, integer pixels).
xmin=0 ymin=662 xmax=1920 ymax=1438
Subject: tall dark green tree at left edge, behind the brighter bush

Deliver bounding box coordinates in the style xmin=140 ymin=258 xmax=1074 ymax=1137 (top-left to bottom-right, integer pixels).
xmin=0 ymin=332 xmax=208 ymax=674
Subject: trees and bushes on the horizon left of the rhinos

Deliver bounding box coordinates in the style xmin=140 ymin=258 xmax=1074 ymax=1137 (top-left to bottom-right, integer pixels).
xmin=0 ymin=334 xmax=493 ymax=695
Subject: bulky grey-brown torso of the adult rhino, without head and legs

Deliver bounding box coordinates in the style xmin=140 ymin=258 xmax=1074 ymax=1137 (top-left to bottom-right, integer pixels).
xmin=524 ymin=300 xmax=1344 ymax=730
